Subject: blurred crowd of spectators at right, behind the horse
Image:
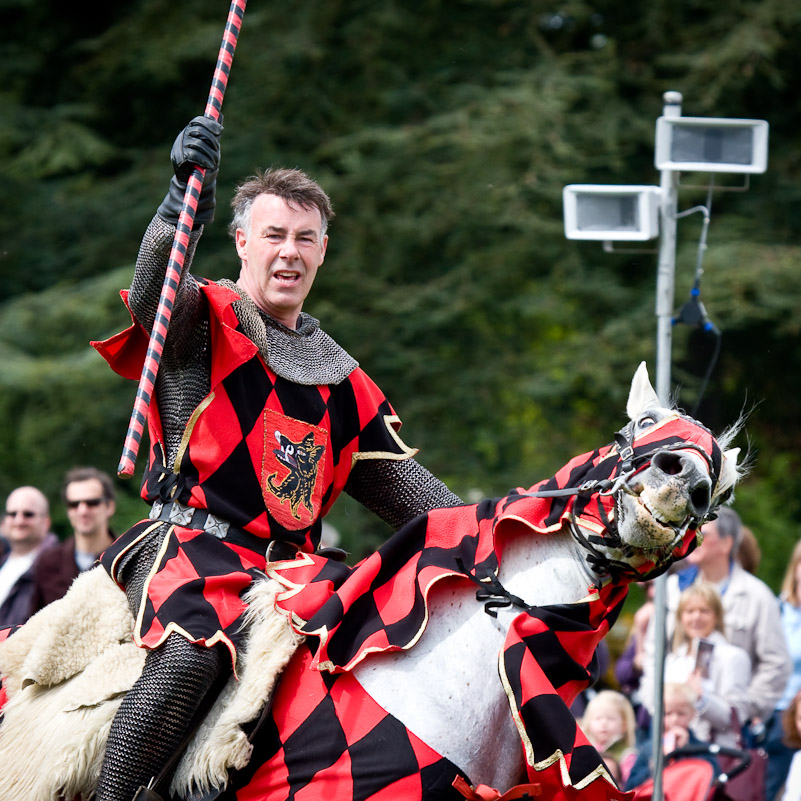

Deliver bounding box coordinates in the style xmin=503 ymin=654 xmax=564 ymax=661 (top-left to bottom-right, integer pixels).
xmin=574 ymin=507 xmax=801 ymax=801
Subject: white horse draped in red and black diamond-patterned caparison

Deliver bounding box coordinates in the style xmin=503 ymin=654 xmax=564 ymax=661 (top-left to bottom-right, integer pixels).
xmin=0 ymin=365 xmax=739 ymax=801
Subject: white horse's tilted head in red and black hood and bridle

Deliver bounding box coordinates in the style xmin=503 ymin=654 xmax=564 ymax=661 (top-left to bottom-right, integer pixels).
xmin=532 ymin=363 xmax=741 ymax=580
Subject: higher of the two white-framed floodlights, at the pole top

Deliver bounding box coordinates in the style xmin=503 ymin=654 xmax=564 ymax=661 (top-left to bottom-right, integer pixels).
xmin=654 ymin=117 xmax=768 ymax=173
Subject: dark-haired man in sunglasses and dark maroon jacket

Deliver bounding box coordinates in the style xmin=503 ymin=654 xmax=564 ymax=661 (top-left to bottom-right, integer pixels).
xmin=30 ymin=467 xmax=116 ymax=614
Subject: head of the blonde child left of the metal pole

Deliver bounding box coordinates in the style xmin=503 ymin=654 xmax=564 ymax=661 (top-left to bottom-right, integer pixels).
xmin=581 ymin=690 xmax=637 ymax=786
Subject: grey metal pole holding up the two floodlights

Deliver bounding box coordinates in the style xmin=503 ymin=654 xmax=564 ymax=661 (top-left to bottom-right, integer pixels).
xmin=651 ymin=92 xmax=682 ymax=801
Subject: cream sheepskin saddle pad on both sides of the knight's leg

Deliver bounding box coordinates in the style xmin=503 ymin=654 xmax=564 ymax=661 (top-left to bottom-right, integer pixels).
xmin=0 ymin=567 xmax=302 ymax=801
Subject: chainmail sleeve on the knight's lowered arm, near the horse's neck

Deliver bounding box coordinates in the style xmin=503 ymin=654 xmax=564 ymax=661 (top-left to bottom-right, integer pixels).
xmin=345 ymin=459 xmax=463 ymax=531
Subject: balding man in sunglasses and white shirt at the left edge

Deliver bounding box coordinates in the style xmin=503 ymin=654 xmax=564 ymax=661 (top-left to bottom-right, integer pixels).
xmin=0 ymin=487 xmax=55 ymax=628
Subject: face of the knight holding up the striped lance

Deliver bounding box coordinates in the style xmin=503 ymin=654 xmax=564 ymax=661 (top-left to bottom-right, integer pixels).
xmin=236 ymin=195 xmax=328 ymax=328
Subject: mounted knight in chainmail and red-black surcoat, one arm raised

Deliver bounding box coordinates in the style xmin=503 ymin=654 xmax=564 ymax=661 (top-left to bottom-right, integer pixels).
xmin=84 ymin=117 xmax=461 ymax=801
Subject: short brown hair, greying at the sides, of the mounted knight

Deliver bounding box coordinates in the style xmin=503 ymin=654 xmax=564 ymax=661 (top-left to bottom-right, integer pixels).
xmin=228 ymin=168 xmax=334 ymax=238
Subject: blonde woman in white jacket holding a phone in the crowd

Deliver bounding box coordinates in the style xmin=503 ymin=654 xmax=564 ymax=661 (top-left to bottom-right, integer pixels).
xmin=642 ymin=582 xmax=751 ymax=747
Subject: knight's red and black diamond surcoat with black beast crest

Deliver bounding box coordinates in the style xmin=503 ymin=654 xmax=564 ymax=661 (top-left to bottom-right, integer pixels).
xmin=93 ymin=282 xmax=415 ymax=656
